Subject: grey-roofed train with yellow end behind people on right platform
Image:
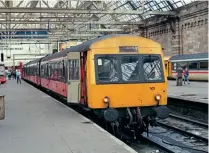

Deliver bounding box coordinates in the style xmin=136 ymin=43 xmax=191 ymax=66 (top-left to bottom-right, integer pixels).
xmin=164 ymin=53 xmax=209 ymax=81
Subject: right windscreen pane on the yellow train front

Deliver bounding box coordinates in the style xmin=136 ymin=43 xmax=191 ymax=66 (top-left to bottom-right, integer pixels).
xmin=142 ymin=56 xmax=163 ymax=81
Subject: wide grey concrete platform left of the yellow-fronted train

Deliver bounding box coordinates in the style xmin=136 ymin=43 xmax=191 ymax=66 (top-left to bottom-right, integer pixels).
xmin=0 ymin=80 xmax=135 ymax=153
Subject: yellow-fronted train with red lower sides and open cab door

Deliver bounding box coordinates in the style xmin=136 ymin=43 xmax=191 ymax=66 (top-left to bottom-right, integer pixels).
xmin=23 ymin=35 xmax=169 ymax=138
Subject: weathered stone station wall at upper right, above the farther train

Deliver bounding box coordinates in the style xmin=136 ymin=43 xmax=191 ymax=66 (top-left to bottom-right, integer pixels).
xmin=131 ymin=1 xmax=208 ymax=56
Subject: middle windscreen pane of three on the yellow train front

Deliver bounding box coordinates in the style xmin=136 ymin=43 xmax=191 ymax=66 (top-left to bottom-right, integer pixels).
xmin=121 ymin=56 xmax=140 ymax=81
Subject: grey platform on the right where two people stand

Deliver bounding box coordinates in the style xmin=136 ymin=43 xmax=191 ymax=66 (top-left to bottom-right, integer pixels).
xmin=168 ymin=80 xmax=208 ymax=103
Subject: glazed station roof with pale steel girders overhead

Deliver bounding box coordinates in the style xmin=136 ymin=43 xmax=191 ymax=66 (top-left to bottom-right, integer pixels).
xmin=0 ymin=0 xmax=193 ymax=42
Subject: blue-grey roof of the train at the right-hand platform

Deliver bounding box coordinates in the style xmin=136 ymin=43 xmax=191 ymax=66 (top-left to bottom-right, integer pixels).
xmin=169 ymin=53 xmax=208 ymax=61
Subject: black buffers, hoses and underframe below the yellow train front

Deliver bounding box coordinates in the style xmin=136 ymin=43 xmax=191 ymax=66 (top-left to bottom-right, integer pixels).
xmin=94 ymin=106 xmax=169 ymax=139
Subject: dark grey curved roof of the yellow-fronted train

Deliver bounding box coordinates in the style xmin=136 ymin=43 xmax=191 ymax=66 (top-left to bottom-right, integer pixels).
xmin=42 ymin=34 xmax=153 ymax=61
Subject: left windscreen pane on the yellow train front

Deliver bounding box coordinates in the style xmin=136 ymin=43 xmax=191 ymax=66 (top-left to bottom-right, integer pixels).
xmin=97 ymin=56 xmax=119 ymax=82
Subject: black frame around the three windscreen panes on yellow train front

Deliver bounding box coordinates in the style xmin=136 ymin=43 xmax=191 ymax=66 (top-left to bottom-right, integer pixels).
xmin=94 ymin=54 xmax=166 ymax=85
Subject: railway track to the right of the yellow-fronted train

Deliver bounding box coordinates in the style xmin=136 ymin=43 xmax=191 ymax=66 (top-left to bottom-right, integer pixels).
xmin=142 ymin=114 xmax=208 ymax=153
